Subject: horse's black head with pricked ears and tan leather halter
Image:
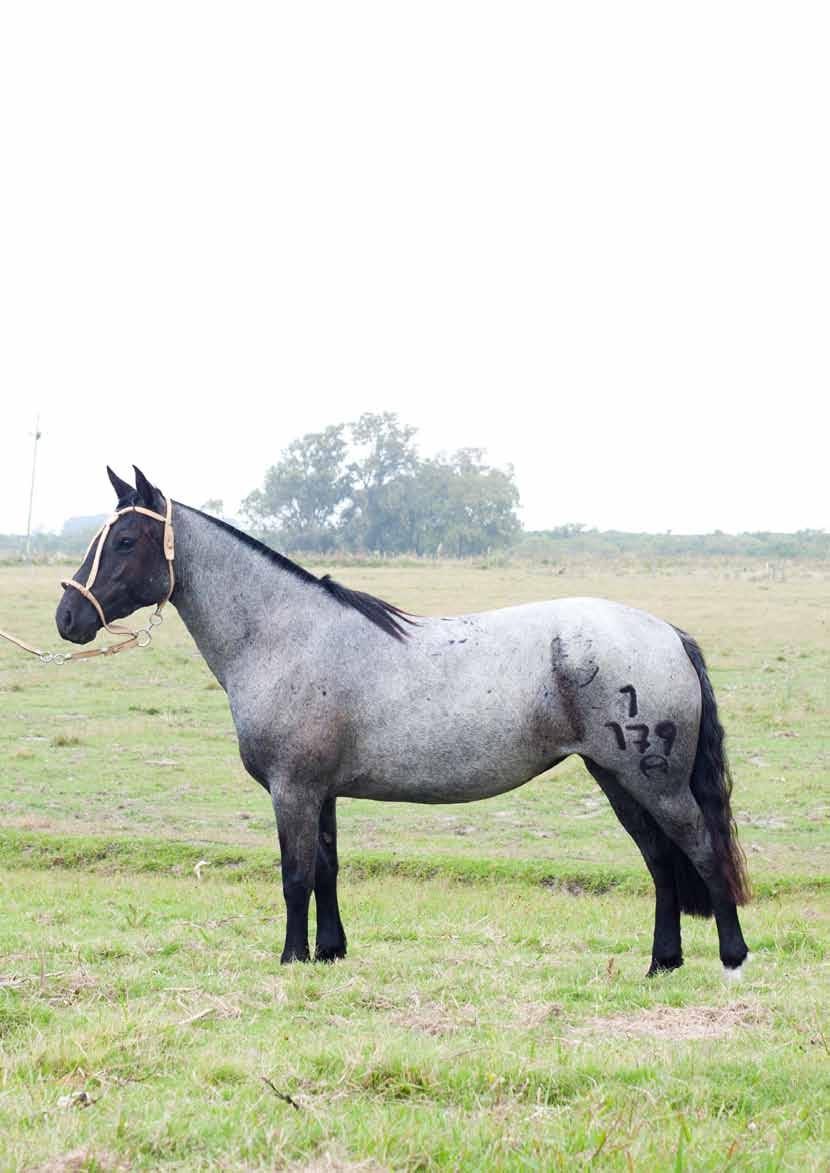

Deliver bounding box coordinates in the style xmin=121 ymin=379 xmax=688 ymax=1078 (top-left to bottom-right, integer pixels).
xmin=55 ymin=468 xmax=174 ymax=644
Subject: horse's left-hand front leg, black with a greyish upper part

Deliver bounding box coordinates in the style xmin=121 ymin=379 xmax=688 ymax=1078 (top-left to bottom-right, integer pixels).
xmin=271 ymin=780 xmax=322 ymax=964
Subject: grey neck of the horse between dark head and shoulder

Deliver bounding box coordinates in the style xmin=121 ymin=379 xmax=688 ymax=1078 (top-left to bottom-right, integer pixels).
xmin=172 ymin=506 xmax=317 ymax=685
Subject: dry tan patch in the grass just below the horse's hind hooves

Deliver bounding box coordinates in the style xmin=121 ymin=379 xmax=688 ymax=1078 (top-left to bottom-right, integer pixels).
xmin=571 ymin=1002 xmax=766 ymax=1042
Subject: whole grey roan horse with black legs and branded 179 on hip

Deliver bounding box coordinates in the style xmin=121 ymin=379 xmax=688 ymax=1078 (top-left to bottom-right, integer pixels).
xmin=55 ymin=466 xmax=749 ymax=977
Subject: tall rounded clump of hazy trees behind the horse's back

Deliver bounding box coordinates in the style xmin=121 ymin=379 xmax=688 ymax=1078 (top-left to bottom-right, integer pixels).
xmin=241 ymin=412 xmax=521 ymax=557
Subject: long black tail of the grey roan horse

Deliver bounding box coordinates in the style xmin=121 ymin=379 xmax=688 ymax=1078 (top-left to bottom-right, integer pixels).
xmin=674 ymin=628 xmax=750 ymax=916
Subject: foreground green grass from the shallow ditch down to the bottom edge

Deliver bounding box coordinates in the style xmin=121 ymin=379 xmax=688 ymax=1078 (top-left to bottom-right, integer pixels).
xmin=0 ymin=869 xmax=830 ymax=1169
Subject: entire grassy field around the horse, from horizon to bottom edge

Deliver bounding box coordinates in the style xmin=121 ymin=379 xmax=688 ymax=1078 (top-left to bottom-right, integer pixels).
xmin=0 ymin=563 xmax=830 ymax=1169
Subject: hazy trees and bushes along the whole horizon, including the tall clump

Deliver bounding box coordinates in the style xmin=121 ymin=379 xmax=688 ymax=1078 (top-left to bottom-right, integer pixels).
xmin=0 ymin=412 xmax=830 ymax=562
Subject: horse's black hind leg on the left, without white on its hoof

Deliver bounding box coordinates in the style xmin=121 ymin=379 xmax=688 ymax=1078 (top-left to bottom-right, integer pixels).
xmin=584 ymin=758 xmax=690 ymax=977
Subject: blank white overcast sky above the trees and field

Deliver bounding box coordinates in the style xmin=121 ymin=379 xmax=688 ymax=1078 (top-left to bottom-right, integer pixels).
xmin=0 ymin=0 xmax=830 ymax=531
